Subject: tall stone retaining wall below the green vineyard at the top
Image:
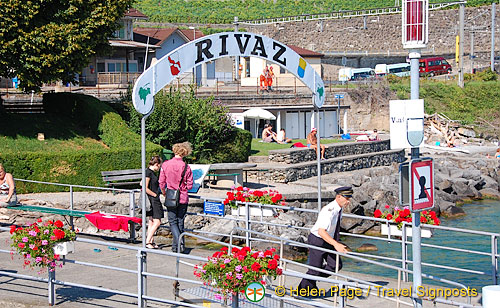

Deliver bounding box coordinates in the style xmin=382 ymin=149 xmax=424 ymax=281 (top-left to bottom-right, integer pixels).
xmin=242 ymin=6 xmax=500 ymax=54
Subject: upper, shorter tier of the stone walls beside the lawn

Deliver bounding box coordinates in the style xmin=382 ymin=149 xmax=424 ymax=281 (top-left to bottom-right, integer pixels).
xmin=269 ymin=140 xmax=390 ymax=164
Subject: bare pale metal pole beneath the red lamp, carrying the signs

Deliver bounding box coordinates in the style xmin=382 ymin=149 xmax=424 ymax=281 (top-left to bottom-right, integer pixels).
xmin=409 ymin=49 xmax=422 ymax=308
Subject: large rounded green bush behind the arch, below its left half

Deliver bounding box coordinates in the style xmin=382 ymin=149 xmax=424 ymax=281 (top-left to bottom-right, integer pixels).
xmin=125 ymin=91 xmax=251 ymax=163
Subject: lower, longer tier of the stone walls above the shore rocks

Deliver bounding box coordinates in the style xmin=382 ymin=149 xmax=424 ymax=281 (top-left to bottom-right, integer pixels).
xmin=266 ymin=150 xmax=406 ymax=183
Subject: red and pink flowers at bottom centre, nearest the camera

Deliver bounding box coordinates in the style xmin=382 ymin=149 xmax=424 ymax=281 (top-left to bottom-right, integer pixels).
xmin=194 ymin=247 xmax=283 ymax=296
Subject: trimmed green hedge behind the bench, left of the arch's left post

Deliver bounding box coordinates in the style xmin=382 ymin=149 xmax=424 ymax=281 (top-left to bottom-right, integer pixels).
xmin=0 ymin=93 xmax=162 ymax=193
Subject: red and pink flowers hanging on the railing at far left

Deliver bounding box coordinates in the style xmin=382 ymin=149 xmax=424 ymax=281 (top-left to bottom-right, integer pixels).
xmin=10 ymin=219 xmax=76 ymax=270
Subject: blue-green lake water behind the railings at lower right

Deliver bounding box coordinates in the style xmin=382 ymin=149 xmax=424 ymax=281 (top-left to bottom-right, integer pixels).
xmin=342 ymin=200 xmax=500 ymax=291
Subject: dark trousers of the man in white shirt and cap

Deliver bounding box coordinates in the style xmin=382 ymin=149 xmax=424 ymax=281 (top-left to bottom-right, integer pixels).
xmin=299 ymin=233 xmax=342 ymax=289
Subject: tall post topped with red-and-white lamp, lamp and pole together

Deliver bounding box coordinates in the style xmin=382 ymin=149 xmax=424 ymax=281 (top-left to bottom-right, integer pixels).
xmin=401 ymin=0 xmax=429 ymax=308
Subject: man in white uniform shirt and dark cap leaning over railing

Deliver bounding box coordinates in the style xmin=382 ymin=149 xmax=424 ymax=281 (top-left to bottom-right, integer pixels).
xmin=298 ymin=186 xmax=352 ymax=293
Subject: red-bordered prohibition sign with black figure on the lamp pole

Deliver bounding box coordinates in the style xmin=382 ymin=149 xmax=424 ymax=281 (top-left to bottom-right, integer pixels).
xmin=410 ymin=158 xmax=434 ymax=212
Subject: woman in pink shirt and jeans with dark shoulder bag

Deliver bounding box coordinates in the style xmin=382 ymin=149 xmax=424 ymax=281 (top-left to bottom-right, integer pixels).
xmin=159 ymin=142 xmax=193 ymax=253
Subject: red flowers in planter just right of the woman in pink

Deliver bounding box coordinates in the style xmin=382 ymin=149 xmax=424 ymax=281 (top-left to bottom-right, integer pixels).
xmin=224 ymin=186 xmax=286 ymax=208
